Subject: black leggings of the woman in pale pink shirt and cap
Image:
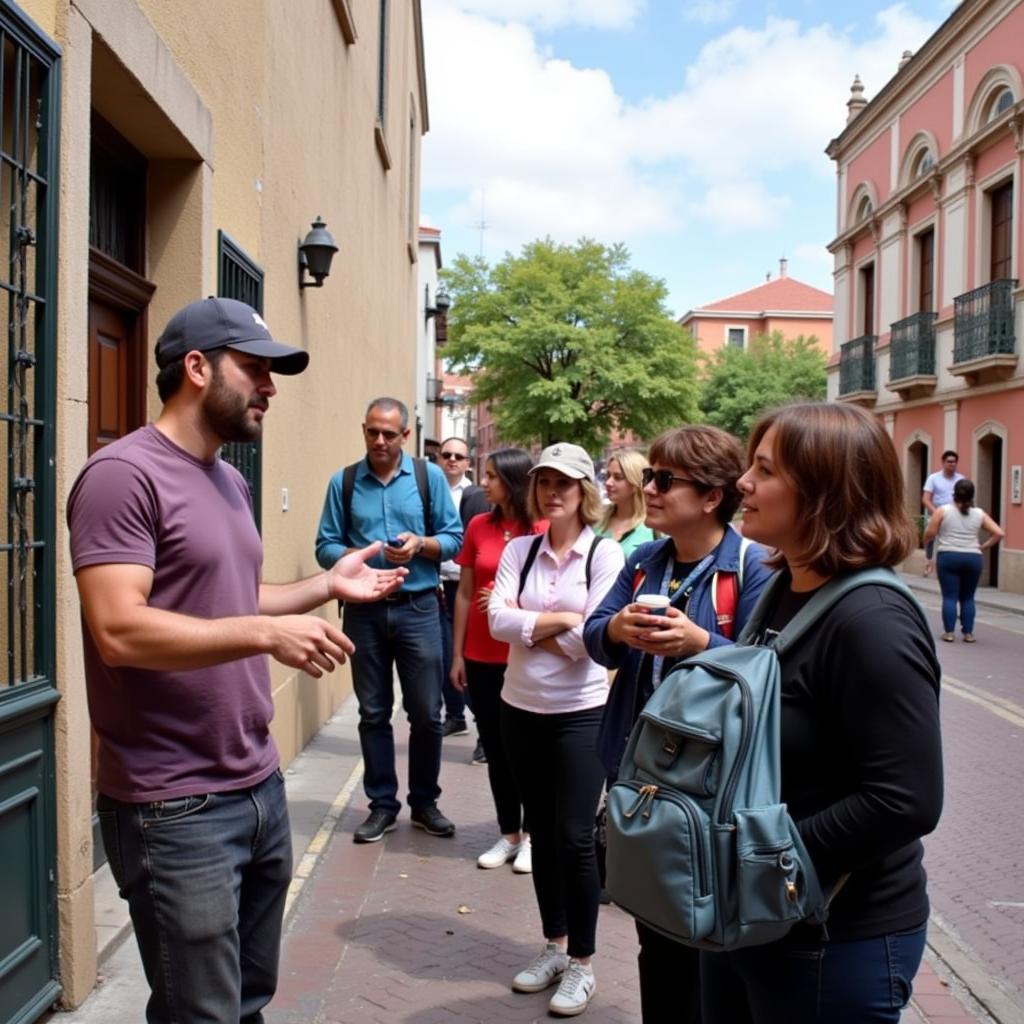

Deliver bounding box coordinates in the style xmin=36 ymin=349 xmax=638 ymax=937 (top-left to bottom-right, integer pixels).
xmin=501 ymin=702 xmax=604 ymax=956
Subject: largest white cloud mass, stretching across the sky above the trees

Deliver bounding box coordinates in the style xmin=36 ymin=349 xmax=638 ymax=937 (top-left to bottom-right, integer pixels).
xmin=424 ymin=0 xmax=934 ymax=260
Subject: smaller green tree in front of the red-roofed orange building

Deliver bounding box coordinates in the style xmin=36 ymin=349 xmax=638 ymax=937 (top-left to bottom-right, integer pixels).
xmin=700 ymin=331 xmax=825 ymax=438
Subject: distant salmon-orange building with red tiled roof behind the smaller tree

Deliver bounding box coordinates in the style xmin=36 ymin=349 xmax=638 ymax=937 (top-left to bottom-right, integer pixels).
xmin=679 ymin=259 xmax=833 ymax=355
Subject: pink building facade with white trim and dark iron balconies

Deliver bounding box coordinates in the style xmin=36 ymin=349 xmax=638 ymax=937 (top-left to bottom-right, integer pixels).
xmin=827 ymin=0 xmax=1024 ymax=593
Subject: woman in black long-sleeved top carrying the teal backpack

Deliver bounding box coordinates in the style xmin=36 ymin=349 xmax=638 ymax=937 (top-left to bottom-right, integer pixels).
xmin=700 ymin=402 xmax=942 ymax=1024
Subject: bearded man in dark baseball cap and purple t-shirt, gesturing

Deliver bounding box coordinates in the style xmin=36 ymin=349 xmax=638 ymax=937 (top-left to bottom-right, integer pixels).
xmin=68 ymin=298 xmax=406 ymax=1024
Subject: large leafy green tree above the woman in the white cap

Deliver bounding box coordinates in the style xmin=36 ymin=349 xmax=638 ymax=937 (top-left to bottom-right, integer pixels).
xmin=443 ymin=239 xmax=697 ymax=452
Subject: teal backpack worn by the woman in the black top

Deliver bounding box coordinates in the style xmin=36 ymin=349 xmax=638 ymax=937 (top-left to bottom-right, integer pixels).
xmin=606 ymin=568 xmax=928 ymax=951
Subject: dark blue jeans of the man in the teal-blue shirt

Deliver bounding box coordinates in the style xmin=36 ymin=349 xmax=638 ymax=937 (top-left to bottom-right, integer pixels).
xmin=344 ymin=590 xmax=442 ymax=814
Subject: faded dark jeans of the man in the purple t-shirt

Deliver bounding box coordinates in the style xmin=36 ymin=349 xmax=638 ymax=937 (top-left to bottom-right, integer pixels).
xmin=96 ymin=771 xmax=292 ymax=1024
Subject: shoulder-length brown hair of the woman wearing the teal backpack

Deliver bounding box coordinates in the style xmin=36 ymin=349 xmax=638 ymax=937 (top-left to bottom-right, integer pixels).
xmin=748 ymin=401 xmax=916 ymax=578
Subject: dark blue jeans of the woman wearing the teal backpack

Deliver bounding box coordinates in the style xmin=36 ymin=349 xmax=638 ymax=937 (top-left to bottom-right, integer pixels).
xmin=700 ymin=925 xmax=927 ymax=1024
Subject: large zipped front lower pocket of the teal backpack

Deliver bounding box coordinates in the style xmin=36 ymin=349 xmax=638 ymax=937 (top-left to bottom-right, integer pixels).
xmin=606 ymin=779 xmax=715 ymax=942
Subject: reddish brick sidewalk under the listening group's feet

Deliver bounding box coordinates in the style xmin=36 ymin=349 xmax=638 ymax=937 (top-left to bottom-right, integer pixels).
xmin=266 ymin=725 xmax=984 ymax=1024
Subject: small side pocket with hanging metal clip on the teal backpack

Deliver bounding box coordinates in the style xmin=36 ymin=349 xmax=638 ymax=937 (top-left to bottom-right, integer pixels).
xmin=733 ymin=804 xmax=821 ymax=944
